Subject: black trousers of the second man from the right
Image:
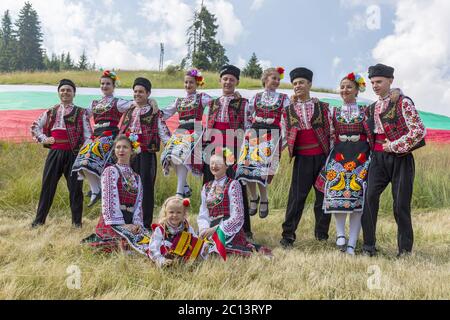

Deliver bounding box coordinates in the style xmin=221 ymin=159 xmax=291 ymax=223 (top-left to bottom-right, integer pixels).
xmin=282 ymin=155 xmax=331 ymax=241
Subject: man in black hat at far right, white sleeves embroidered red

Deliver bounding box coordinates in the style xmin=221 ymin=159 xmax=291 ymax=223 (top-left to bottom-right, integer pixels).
xmin=362 ymin=64 xmax=426 ymax=256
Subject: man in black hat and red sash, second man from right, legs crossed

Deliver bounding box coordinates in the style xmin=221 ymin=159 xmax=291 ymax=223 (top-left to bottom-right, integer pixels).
xmin=280 ymin=68 xmax=331 ymax=248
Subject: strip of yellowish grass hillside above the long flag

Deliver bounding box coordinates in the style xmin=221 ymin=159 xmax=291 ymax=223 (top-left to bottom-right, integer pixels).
xmin=0 ymin=71 xmax=332 ymax=92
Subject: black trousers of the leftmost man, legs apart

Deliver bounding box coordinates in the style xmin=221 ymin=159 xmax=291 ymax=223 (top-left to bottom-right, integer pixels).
xmin=34 ymin=150 xmax=83 ymax=224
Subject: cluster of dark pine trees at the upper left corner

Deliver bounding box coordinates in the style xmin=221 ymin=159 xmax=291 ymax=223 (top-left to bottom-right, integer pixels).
xmin=0 ymin=2 xmax=95 ymax=72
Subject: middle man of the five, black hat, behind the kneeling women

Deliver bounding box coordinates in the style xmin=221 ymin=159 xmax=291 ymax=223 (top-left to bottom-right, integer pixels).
xmin=203 ymin=65 xmax=252 ymax=238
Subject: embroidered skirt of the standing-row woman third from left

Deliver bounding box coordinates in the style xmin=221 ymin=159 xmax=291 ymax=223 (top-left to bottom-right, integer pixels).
xmin=236 ymin=124 xmax=282 ymax=187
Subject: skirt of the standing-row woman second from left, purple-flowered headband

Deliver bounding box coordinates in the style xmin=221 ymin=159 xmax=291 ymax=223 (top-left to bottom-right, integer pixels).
xmin=161 ymin=128 xmax=203 ymax=176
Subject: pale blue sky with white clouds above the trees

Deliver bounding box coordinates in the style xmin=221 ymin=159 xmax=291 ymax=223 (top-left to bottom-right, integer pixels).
xmin=0 ymin=0 xmax=450 ymax=116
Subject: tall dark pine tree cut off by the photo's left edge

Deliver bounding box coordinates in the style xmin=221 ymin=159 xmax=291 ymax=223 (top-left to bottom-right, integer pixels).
xmin=0 ymin=10 xmax=17 ymax=72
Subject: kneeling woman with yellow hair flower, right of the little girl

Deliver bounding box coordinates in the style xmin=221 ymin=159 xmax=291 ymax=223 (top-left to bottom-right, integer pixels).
xmin=197 ymin=148 xmax=272 ymax=257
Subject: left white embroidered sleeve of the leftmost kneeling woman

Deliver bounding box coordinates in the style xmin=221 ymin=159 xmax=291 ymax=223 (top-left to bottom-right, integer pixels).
xmin=101 ymin=167 xmax=125 ymax=225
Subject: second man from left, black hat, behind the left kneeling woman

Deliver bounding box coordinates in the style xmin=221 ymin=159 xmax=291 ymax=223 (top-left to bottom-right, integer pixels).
xmin=120 ymin=78 xmax=170 ymax=229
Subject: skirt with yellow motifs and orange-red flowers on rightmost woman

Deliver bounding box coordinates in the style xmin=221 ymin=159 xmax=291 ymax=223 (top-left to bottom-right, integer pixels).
xmin=323 ymin=141 xmax=370 ymax=214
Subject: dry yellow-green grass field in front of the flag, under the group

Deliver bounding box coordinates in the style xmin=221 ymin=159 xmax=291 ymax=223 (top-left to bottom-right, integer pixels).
xmin=0 ymin=143 xmax=450 ymax=300
